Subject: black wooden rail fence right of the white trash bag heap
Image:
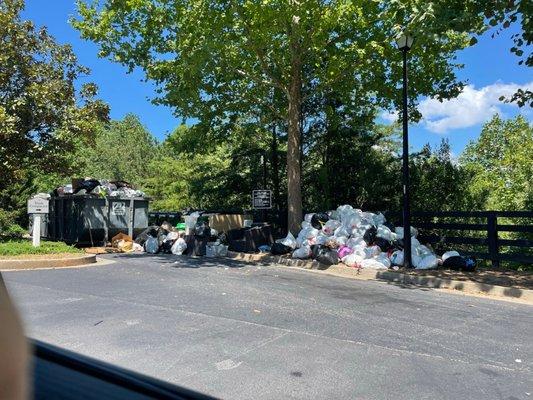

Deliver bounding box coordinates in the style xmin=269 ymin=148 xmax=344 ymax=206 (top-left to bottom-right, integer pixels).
xmin=389 ymin=211 xmax=533 ymax=267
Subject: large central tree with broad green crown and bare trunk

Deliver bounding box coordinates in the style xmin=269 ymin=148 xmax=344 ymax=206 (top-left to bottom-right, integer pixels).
xmin=74 ymin=0 xmax=498 ymax=231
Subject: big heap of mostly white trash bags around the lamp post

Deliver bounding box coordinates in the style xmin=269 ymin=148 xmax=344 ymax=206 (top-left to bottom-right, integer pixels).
xmin=271 ymin=205 xmax=475 ymax=270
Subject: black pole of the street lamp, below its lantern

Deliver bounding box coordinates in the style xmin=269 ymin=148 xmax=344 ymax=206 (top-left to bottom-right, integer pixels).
xmin=402 ymin=48 xmax=412 ymax=268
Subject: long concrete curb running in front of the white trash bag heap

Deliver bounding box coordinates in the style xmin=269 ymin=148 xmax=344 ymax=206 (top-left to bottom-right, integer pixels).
xmin=228 ymin=252 xmax=533 ymax=304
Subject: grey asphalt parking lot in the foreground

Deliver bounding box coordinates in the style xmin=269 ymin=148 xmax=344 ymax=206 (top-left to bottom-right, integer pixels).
xmin=3 ymin=255 xmax=533 ymax=400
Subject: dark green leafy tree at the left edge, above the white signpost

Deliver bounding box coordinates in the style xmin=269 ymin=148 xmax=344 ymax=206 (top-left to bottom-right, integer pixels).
xmin=0 ymin=0 xmax=108 ymax=225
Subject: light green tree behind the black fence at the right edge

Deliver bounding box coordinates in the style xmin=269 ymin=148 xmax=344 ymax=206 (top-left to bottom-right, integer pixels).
xmin=461 ymin=115 xmax=533 ymax=210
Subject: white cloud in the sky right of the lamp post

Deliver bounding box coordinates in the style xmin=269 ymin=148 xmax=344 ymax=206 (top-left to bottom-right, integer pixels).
xmin=381 ymin=82 xmax=533 ymax=133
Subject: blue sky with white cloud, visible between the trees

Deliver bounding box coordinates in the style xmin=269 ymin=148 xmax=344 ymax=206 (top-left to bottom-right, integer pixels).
xmin=23 ymin=0 xmax=533 ymax=155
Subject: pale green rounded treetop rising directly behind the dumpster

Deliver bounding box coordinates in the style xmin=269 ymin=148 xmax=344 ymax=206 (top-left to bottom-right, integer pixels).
xmin=77 ymin=114 xmax=157 ymax=184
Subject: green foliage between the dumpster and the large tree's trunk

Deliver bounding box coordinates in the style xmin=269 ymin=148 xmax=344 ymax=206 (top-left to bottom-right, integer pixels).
xmin=144 ymin=124 xmax=282 ymax=210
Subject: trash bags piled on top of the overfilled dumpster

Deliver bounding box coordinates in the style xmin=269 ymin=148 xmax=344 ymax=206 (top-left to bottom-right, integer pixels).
xmin=53 ymin=178 xmax=146 ymax=198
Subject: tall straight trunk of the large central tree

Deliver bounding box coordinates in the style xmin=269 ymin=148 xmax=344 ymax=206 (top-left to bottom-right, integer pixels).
xmin=287 ymin=63 xmax=302 ymax=235
